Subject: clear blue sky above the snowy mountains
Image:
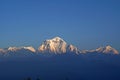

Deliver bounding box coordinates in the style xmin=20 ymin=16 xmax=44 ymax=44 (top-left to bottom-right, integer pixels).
xmin=0 ymin=0 xmax=120 ymax=51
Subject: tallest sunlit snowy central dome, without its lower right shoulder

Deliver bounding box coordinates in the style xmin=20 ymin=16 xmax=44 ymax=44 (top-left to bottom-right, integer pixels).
xmin=38 ymin=37 xmax=67 ymax=53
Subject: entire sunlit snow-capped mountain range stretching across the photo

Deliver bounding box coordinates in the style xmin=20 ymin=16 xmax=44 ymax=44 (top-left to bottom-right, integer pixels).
xmin=0 ymin=37 xmax=119 ymax=55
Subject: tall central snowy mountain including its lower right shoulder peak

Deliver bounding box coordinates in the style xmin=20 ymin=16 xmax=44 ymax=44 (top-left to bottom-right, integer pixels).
xmin=38 ymin=37 xmax=79 ymax=53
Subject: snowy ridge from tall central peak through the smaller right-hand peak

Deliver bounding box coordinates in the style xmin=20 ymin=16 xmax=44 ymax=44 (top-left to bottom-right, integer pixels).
xmin=38 ymin=37 xmax=119 ymax=54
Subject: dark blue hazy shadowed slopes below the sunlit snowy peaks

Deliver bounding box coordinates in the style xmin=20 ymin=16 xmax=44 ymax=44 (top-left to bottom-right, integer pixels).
xmin=0 ymin=53 xmax=120 ymax=80
